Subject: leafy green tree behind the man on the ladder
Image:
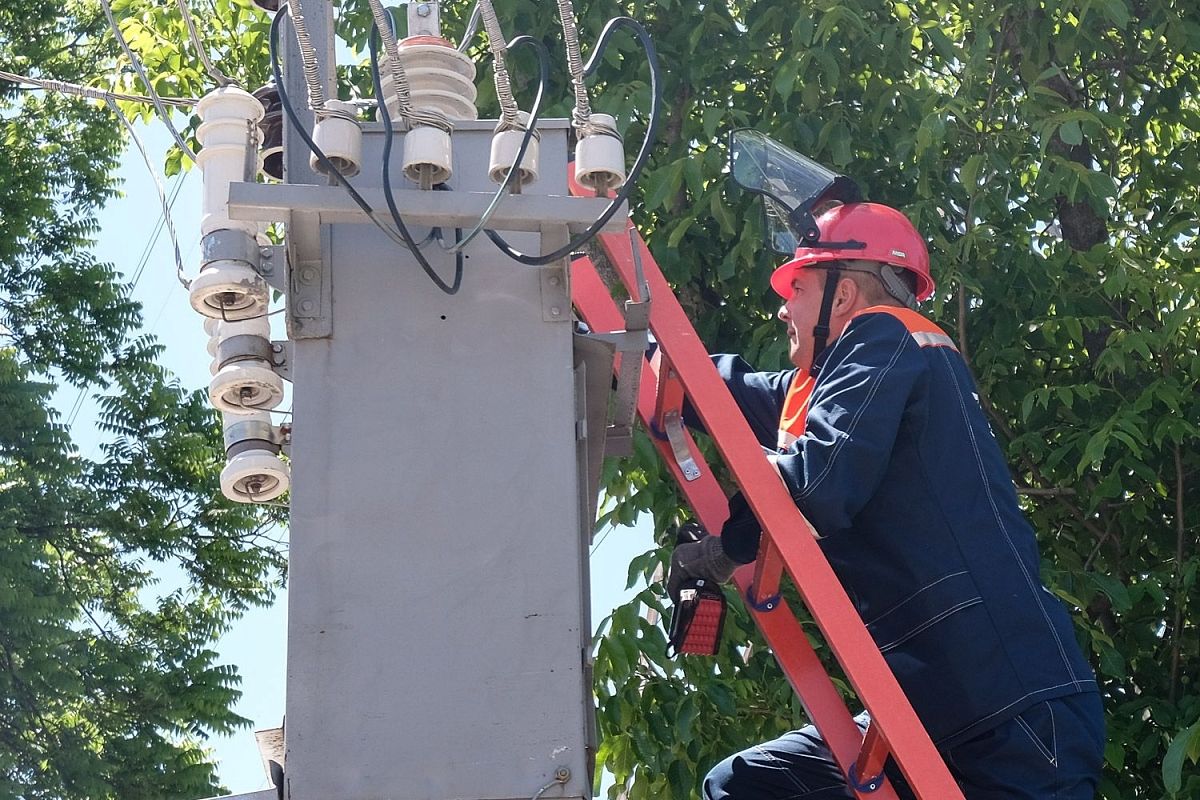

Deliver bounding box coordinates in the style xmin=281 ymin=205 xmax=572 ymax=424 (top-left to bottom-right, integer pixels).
xmin=14 ymin=0 xmax=1200 ymax=800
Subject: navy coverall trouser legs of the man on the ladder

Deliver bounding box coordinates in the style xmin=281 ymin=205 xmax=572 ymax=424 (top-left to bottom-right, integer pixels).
xmin=703 ymin=692 xmax=1104 ymax=800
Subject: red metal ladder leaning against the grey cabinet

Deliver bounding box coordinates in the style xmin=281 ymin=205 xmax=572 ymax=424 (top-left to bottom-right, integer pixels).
xmin=571 ymin=220 xmax=962 ymax=800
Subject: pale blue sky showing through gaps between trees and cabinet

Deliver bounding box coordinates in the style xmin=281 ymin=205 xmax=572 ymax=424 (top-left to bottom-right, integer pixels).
xmin=82 ymin=118 xmax=650 ymax=794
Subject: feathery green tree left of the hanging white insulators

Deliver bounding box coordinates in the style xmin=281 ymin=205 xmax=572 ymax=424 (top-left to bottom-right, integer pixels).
xmin=0 ymin=0 xmax=283 ymax=799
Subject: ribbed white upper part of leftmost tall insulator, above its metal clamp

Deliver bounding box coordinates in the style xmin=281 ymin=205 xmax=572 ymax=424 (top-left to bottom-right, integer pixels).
xmin=196 ymin=86 xmax=263 ymax=236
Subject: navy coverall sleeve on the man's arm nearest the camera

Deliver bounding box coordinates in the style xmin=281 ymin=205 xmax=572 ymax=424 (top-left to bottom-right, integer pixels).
xmin=778 ymin=313 xmax=926 ymax=536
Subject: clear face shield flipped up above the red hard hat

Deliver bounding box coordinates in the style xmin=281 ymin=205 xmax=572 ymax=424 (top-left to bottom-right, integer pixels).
xmin=730 ymin=128 xmax=862 ymax=255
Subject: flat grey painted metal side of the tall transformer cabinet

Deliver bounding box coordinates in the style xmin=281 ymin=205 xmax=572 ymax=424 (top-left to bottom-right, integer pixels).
xmin=286 ymin=125 xmax=602 ymax=800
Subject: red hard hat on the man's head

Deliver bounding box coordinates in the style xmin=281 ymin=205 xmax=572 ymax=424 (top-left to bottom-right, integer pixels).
xmin=770 ymin=203 xmax=934 ymax=300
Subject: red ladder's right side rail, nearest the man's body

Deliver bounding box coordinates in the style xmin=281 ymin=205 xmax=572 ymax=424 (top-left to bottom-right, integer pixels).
xmin=576 ymin=223 xmax=962 ymax=800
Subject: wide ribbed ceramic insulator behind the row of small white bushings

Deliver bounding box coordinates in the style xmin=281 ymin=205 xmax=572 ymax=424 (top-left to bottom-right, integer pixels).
xmin=379 ymin=36 xmax=479 ymax=120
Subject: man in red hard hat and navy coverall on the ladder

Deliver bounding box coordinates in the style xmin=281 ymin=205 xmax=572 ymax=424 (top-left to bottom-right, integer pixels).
xmin=667 ymin=203 xmax=1104 ymax=800
